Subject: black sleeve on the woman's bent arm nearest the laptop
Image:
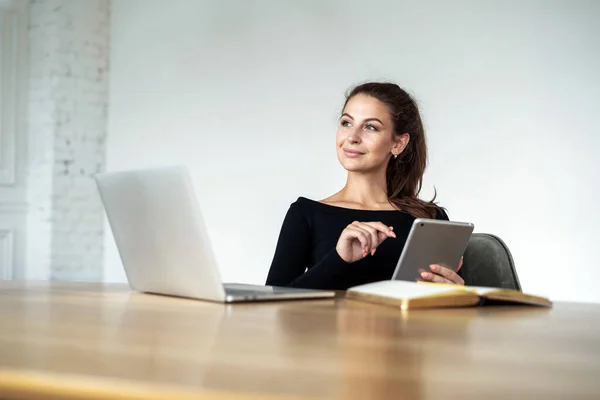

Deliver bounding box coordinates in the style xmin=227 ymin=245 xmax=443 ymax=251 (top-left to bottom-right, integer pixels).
xmin=266 ymin=202 xmax=348 ymax=289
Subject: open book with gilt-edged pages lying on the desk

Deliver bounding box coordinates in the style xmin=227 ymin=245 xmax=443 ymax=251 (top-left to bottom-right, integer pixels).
xmin=346 ymin=280 xmax=552 ymax=310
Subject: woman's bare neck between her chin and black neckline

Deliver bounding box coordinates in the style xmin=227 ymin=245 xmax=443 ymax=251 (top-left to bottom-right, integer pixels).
xmin=340 ymin=172 xmax=388 ymax=206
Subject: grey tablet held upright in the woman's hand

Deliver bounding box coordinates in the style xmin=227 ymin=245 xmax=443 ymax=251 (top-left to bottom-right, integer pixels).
xmin=392 ymin=218 xmax=474 ymax=282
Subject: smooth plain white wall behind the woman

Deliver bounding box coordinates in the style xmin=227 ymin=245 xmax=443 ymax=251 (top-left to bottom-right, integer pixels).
xmin=105 ymin=0 xmax=600 ymax=302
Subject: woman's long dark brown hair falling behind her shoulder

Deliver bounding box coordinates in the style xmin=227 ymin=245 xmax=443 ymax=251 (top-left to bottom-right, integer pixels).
xmin=344 ymin=82 xmax=442 ymax=218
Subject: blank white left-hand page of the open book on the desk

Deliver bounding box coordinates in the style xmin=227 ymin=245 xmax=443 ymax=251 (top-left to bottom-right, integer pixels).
xmin=348 ymin=281 xmax=464 ymax=299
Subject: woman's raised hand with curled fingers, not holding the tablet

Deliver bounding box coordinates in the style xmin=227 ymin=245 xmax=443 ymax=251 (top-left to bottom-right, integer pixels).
xmin=335 ymin=221 xmax=396 ymax=263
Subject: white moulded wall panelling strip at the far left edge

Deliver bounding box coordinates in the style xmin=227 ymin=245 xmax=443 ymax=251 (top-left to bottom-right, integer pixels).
xmin=0 ymin=0 xmax=27 ymax=280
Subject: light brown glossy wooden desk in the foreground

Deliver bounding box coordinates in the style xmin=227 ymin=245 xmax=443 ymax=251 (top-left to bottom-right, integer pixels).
xmin=0 ymin=282 xmax=600 ymax=399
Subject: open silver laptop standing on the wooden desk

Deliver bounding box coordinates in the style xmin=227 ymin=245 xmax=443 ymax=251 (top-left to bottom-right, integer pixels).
xmin=94 ymin=166 xmax=335 ymax=303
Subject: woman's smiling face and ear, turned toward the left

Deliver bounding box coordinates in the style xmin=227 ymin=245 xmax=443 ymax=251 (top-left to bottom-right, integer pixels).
xmin=336 ymin=95 xmax=409 ymax=172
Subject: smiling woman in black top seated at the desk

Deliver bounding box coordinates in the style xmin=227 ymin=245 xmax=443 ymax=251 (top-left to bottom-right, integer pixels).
xmin=266 ymin=82 xmax=464 ymax=290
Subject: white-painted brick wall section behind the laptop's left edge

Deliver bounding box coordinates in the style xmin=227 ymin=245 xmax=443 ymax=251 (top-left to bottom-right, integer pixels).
xmin=27 ymin=0 xmax=110 ymax=281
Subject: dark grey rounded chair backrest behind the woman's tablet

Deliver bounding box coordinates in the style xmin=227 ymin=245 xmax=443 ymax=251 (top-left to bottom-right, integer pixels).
xmin=461 ymin=233 xmax=521 ymax=290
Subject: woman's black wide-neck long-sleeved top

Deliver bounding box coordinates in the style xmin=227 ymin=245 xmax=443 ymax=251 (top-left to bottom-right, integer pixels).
xmin=266 ymin=197 xmax=448 ymax=290
